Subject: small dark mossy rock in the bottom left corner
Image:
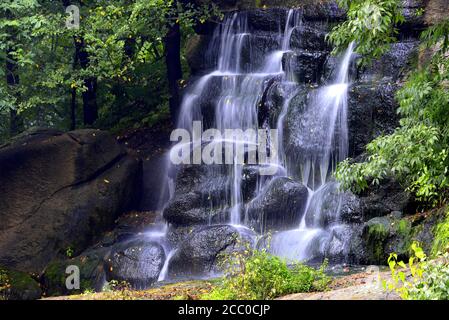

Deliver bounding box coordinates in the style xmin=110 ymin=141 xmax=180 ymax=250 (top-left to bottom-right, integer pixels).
xmin=0 ymin=267 xmax=42 ymax=300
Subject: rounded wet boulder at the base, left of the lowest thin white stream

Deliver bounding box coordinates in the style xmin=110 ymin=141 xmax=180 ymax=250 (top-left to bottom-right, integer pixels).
xmin=106 ymin=240 xmax=166 ymax=288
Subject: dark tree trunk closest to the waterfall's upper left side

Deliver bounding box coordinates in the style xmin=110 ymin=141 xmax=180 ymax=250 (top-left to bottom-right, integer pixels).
xmin=164 ymin=1 xmax=182 ymax=126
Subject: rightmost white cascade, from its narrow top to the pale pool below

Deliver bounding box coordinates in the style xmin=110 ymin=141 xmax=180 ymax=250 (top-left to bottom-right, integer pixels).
xmin=271 ymin=44 xmax=353 ymax=261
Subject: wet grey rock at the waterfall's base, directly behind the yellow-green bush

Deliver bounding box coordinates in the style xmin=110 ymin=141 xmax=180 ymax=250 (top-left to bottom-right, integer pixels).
xmin=168 ymin=225 xmax=254 ymax=278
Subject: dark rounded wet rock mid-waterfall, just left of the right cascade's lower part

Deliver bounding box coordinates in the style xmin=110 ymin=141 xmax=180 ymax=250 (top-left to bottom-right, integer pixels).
xmin=245 ymin=177 xmax=309 ymax=232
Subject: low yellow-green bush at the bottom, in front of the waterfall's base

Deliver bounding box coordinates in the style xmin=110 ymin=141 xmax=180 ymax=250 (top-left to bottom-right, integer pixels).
xmin=202 ymin=245 xmax=330 ymax=300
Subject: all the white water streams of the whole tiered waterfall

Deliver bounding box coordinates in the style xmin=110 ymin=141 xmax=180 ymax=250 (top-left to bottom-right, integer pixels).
xmin=154 ymin=10 xmax=353 ymax=281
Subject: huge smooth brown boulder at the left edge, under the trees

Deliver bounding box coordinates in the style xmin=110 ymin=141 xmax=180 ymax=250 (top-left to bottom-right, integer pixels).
xmin=0 ymin=129 xmax=141 ymax=273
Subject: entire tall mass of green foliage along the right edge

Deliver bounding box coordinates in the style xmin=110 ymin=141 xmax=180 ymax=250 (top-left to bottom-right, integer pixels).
xmin=336 ymin=22 xmax=449 ymax=205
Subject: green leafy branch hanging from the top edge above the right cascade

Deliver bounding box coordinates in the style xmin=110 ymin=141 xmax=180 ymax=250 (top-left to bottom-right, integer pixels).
xmin=328 ymin=0 xmax=404 ymax=64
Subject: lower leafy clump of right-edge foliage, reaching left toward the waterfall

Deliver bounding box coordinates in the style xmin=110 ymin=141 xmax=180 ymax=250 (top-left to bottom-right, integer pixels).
xmin=335 ymin=124 xmax=449 ymax=200
